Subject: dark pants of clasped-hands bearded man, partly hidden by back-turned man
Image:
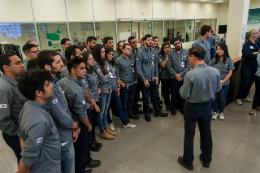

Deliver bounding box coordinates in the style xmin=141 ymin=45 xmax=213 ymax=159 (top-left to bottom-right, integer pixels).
xmin=170 ymin=77 xmax=185 ymax=109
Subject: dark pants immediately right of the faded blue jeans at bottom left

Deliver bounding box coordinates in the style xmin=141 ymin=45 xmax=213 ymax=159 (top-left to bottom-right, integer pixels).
xmin=74 ymin=109 xmax=92 ymax=173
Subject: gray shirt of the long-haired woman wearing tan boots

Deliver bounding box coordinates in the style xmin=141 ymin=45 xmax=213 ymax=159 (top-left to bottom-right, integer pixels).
xmin=93 ymin=61 xmax=112 ymax=94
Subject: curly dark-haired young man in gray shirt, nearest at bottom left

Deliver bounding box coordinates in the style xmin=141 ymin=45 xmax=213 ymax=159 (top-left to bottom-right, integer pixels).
xmin=17 ymin=70 xmax=61 ymax=173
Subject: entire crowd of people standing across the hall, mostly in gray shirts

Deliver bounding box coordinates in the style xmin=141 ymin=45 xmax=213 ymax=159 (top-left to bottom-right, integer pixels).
xmin=0 ymin=25 xmax=260 ymax=173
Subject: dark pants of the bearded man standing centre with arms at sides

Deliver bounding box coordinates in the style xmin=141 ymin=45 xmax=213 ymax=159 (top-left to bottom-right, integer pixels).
xmin=142 ymin=81 xmax=162 ymax=115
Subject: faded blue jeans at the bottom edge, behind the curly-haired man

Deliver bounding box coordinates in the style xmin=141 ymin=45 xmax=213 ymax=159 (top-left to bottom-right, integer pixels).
xmin=60 ymin=140 xmax=75 ymax=173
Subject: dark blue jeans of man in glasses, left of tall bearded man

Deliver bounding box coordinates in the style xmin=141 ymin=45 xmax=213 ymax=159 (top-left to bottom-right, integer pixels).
xmin=120 ymin=84 xmax=136 ymax=117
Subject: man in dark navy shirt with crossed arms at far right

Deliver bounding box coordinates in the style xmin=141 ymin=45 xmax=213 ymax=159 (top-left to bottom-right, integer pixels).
xmin=237 ymin=29 xmax=260 ymax=105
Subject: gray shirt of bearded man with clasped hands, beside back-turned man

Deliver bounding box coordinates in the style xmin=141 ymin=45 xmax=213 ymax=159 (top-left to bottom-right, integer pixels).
xmin=167 ymin=49 xmax=190 ymax=79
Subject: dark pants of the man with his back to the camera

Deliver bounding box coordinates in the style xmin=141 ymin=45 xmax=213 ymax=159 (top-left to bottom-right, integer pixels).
xmin=183 ymin=102 xmax=213 ymax=166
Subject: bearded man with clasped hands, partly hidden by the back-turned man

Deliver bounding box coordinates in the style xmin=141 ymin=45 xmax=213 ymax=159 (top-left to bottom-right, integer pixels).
xmin=167 ymin=37 xmax=190 ymax=115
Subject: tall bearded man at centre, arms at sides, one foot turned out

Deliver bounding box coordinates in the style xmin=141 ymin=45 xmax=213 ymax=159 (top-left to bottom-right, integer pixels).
xmin=136 ymin=34 xmax=168 ymax=122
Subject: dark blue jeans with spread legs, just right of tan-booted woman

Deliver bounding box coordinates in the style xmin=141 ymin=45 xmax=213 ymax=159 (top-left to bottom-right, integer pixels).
xmin=107 ymin=91 xmax=128 ymax=125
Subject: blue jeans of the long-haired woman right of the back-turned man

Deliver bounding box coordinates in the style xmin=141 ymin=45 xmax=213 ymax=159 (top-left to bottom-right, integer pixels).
xmin=213 ymin=84 xmax=229 ymax=113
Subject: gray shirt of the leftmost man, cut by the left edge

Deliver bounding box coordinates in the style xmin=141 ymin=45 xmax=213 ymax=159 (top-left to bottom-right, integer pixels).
xmin=0 ymin=74 xmax=26 ymax=137
